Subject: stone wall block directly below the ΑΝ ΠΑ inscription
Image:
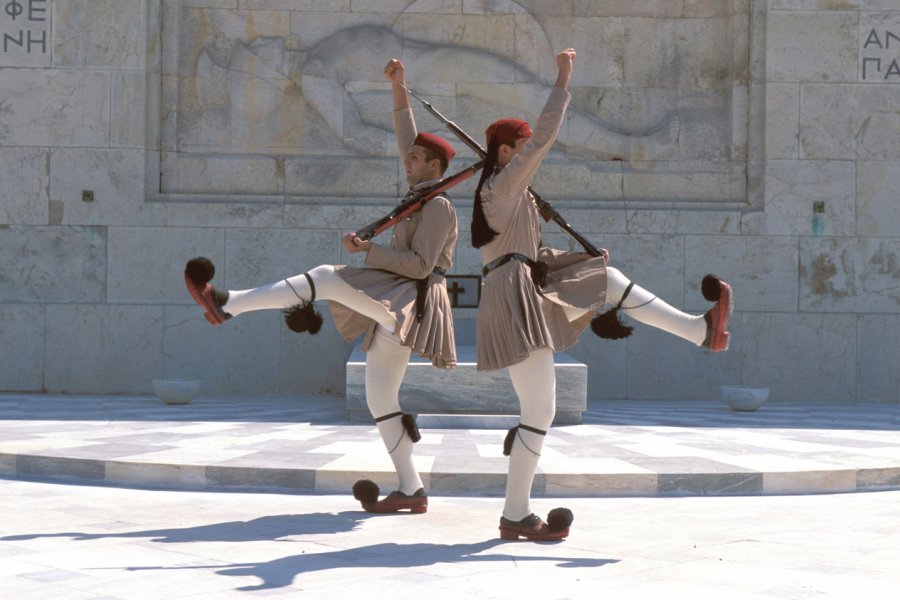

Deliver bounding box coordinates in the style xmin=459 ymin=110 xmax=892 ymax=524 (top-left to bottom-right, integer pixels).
xmin=800 ymin=84 xmax=900 ymax=160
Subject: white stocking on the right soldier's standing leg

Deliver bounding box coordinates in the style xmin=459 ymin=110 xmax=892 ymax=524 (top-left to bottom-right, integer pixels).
xmin=503 ymin=348 xmax=556 ymax=521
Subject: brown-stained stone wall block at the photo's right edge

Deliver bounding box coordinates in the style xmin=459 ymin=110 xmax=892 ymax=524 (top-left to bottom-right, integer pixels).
xmin=799 ymin=238 xmax=900 ymax=314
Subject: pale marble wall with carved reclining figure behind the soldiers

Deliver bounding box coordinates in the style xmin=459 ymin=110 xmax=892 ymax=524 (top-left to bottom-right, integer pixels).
xmin=0 ymin=0 xmax=900 ymax=402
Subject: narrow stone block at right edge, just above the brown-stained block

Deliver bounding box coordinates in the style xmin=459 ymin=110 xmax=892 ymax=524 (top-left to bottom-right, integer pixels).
xmin=856 ymin=160 xmax=900 ymax=237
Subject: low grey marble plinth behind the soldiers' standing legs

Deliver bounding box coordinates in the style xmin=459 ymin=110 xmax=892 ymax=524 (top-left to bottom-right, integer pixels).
xmin=346 ymin=344 xmax=587 ymax=425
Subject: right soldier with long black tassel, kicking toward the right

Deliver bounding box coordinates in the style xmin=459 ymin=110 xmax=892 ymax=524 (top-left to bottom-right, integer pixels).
xmin=472 ymin=49 xmax=732 ymax=540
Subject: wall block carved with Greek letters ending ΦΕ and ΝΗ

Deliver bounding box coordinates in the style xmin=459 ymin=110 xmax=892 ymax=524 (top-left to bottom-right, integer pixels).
xmin=0 ymin=0 xmax=50 ymax=66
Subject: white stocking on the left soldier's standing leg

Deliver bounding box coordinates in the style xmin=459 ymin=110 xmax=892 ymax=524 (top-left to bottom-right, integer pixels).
xmin=366 ymin=328 xmax=423 ymax=494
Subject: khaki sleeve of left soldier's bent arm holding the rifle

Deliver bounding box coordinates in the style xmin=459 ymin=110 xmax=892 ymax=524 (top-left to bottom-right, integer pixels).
xmin=366 ymin=196 xmax=453 ymax=279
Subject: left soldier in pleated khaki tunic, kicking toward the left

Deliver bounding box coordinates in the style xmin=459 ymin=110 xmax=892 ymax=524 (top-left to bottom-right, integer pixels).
xmin=185 ymin=60 xmax=457 ymax=513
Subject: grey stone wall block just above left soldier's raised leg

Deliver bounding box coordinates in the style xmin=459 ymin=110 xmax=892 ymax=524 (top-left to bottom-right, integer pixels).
xmin=223 ymin=229 xmax=343 ymax=289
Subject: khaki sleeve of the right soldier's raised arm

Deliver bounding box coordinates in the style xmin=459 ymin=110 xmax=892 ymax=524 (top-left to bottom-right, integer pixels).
xmin=483 ymin=86 xmax=571 ymax=226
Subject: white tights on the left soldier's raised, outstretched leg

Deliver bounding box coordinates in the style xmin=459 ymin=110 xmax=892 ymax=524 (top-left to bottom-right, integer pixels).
xmin=222 ymin=265 xmax=396 ymax=331
